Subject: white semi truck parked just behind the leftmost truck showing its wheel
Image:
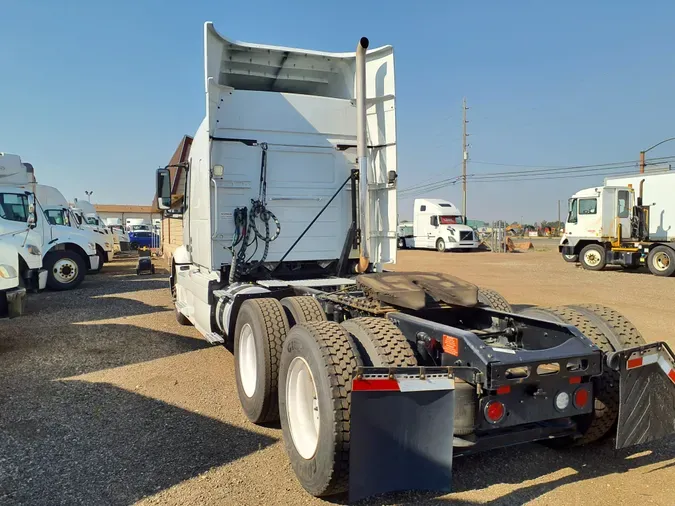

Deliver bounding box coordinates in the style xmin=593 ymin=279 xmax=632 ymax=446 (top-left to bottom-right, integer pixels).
xmin=35 ymin=184 xmax=113 ymax=273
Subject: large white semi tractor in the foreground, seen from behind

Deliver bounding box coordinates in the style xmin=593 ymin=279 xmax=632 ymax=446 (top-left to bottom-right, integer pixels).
xmin=157 ymin=23 xmax=675 ymax=500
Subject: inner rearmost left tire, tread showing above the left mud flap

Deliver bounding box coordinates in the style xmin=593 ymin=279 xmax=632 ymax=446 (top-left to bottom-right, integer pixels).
xmin=342 ymin=316 xmax=417 ymax=367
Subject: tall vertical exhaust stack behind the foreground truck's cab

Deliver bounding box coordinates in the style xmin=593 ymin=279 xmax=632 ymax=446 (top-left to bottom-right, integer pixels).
xmin=356 ymin=37 xmax=370 ymax=272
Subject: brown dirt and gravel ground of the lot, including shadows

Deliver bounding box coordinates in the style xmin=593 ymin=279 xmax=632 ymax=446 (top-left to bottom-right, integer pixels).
xmin=0 ymin=253 xmax=675 ymax=505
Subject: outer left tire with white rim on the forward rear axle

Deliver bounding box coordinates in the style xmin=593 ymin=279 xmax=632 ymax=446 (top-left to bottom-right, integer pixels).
xmin=234 ymin=298 xmax=288 ymax=424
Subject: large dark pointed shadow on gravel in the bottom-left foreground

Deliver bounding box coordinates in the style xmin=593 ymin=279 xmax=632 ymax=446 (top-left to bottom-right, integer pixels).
xmin=0 ymin=380 xmax=275 ymax=506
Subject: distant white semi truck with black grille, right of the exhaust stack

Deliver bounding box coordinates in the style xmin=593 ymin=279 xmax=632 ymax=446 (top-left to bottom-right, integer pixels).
xmin=398 ymin=199 xmax=480 ymax=252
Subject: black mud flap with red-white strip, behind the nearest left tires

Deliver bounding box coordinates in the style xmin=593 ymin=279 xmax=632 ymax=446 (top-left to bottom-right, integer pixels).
xmin=349 ymin=367 xmax=455 ymax=502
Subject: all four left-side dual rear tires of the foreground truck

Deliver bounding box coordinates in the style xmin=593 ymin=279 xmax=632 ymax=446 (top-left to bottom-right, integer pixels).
xmin=234 ymin=297 xmax=417 ymax=497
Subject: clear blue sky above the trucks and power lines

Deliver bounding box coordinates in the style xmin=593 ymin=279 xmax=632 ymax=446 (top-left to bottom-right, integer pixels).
xmin=0 ymin=0 xmax=675 ymax=221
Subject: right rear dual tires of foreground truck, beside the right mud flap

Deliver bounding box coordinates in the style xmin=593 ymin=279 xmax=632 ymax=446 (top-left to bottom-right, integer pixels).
xmin=521 ymin=304 xmax=645 ymax=447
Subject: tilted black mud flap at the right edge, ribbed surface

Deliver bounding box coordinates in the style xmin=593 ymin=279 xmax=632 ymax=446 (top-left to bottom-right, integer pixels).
xmin=608 ymin=342 xmax=675 ymax=449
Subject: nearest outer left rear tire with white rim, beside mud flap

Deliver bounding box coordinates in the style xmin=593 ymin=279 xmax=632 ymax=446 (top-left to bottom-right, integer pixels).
xmin=279 ymin=322 xmax=358 ymax=497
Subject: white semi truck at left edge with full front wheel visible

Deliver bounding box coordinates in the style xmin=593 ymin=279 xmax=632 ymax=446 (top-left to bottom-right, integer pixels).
xmin=0 ymin=153 xmax=98 ymax=290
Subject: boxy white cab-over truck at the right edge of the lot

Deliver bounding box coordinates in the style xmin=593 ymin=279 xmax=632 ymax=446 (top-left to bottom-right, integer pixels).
xmin=559 ymin=171 xmax=675 ymax=276
